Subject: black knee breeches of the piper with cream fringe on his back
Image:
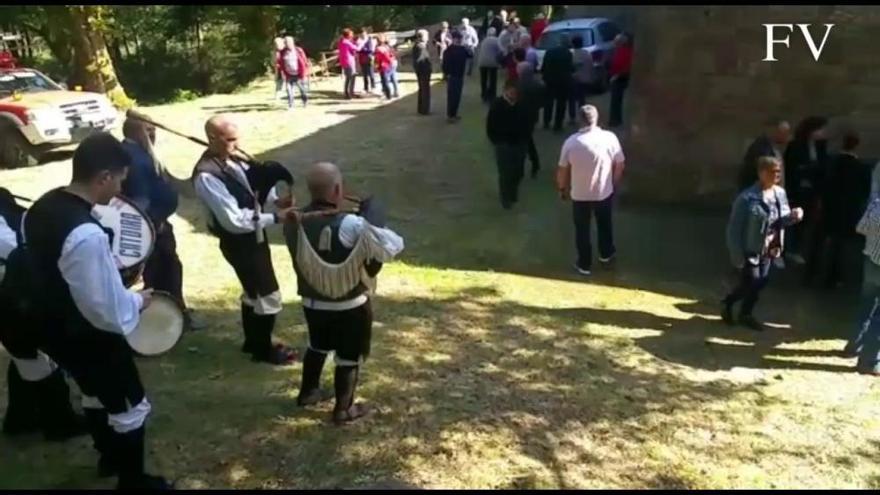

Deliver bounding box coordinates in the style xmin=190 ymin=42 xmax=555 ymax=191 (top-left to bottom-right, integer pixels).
xmin=303 ymin=300 xmax=373 ymax=362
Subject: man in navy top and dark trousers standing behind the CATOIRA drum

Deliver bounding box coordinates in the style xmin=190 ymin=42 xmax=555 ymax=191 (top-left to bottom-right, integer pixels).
xmin=122 ymin=118 xmax=205 ymax=330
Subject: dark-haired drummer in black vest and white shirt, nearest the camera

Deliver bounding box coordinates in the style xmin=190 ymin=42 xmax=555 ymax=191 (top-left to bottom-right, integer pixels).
xmin=23 ymin=132 xmax=170 ymax=489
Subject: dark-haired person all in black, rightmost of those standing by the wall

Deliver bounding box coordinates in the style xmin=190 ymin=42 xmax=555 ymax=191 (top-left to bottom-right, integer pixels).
xmin=818 ymin=132 xmax=871 ymax=289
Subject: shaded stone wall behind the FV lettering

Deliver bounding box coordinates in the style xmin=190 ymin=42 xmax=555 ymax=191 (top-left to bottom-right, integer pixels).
xmin=568 ymin=6 xmax=880 ymax=204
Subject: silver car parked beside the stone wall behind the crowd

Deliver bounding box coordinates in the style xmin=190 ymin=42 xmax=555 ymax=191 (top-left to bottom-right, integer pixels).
xmin=535 ymin=17 xmax=621 ymax=92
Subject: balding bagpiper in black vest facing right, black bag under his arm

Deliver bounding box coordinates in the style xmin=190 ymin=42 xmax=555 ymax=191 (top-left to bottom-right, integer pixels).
xmin=192 ymin=115 xmax=296 ymax=365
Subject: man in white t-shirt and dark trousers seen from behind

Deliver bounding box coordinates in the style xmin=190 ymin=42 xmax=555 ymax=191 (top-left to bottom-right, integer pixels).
xmin=556 ymin=105 xmax=624 ymax=275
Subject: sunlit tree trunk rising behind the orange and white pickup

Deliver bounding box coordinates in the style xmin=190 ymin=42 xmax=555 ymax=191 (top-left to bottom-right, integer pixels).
xmin=68 ymin=5 xmax=132 ymax=108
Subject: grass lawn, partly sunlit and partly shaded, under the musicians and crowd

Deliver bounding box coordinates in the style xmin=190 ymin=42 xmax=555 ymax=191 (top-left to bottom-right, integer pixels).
xmin=0 ymin=68 xmax=880 ymax=489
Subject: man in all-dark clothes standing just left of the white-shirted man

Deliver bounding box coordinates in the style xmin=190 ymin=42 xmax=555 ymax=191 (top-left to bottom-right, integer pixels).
xmin=486 ymin=81 xmax=529 ymax=210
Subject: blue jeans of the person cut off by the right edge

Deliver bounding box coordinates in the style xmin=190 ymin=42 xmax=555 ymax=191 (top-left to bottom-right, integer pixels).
xmin=845 ymin=257 xmax=880 ymax=371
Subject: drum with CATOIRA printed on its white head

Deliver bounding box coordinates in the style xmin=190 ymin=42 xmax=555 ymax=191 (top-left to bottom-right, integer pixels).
xmin=92 ymin=196 xmax=156 ymax=287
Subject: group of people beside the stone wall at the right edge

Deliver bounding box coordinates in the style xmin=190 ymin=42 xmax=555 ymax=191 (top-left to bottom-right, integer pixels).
xmin=721 ymin=116 xmax=880 ymax=376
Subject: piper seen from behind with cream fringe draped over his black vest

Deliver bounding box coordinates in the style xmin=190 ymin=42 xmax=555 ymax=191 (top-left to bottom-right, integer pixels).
xmin=284 ymin=162 xmax=403 ymax=424
